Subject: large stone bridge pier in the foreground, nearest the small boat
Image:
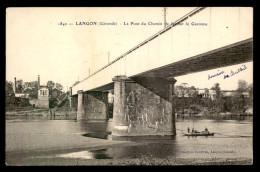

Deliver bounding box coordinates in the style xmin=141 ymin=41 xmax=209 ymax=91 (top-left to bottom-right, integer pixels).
xmin=112 ymin=76 xmax=176 ymax=136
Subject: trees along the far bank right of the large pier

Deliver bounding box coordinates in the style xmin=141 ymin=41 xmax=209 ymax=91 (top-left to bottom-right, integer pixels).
xmin=174 ymin=80 xmax=253 ymax=112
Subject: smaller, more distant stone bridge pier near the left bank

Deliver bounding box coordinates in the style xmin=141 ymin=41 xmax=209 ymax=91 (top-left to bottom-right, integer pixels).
xmin=77 ymin=90 xmax=108 ymax=120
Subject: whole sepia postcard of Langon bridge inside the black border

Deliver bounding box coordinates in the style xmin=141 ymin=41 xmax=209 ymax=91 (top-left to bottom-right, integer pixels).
xmin=5 ymin=6 xmax=253 ymax=166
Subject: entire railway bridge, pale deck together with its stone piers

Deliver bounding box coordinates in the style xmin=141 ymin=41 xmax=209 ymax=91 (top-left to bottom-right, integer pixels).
xmin=71 ymin=7 xmax=253 ymax=136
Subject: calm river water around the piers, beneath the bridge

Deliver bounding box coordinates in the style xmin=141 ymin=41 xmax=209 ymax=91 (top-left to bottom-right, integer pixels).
xmin=6 ymin=117 xmax=253 ymax=165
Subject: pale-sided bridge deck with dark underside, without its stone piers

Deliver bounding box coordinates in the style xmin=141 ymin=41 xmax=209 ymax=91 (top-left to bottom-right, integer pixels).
xmin=72 ymin=7 xmax=253 ymax=95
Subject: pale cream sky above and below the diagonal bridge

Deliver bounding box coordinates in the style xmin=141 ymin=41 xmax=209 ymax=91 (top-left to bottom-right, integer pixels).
xmin=6 ymin=7 xmax=253 ymax=91
